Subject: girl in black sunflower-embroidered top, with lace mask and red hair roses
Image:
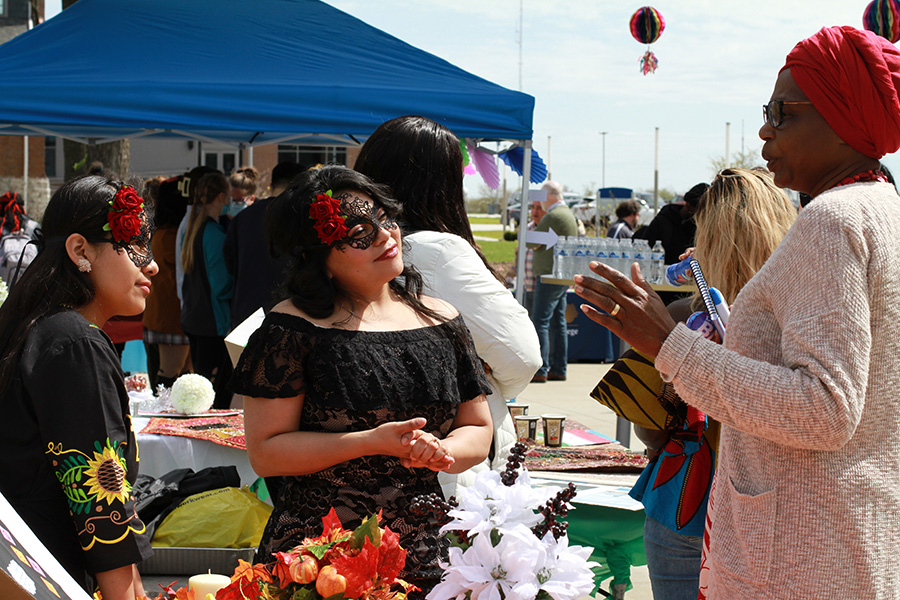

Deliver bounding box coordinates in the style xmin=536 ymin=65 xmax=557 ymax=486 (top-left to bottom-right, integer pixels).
xmin=0 ymin=176 xmax=157 ymax=600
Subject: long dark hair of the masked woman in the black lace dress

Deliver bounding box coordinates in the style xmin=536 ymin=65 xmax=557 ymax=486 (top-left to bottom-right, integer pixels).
xmin=266 ymin=166 xmax=446 ymax=322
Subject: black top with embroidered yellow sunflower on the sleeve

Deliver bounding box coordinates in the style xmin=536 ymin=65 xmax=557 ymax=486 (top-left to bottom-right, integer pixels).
xmin=0 ymin=310 xmax=152 ymax=592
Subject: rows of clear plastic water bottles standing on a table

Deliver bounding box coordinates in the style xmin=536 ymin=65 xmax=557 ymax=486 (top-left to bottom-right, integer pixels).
xmin=553 ymin=236 xmax=665 ymax=283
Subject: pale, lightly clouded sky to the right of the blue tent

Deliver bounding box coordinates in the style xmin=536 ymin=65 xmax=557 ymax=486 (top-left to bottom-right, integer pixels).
xmin=46 ymin=0 xmax=900 ymax=196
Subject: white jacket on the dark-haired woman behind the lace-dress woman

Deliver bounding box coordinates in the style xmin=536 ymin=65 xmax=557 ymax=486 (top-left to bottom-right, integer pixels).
xmin=403 ymin=231 xmax=541 ymax=497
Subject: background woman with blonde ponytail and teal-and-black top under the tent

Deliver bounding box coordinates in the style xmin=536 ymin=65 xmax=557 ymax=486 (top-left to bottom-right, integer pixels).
xmin=181 ymin=173 xmax=234 ymax=408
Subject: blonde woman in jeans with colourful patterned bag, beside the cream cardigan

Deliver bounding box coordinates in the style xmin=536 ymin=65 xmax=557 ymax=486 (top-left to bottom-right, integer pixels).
xmin=593 ymin=169 xmax=797 ymax=600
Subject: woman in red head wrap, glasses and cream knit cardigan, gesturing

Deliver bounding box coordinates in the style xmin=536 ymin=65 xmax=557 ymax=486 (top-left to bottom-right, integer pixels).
xmin=575 ymin=27 xmax=900 ymax=600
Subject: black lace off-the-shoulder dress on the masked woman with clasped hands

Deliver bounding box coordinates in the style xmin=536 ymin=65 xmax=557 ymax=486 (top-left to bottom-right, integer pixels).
xmin=232 ymin=313 xmax=490 ymax=587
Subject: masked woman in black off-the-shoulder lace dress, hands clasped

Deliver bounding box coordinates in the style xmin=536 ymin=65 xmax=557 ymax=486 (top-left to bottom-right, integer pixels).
xmin=227 ymin=167 xmax=492 ymax=591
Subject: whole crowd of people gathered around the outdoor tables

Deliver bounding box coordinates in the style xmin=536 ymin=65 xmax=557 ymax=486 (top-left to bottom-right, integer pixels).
xmin=0 ymin=21 xmax=900 ymax=600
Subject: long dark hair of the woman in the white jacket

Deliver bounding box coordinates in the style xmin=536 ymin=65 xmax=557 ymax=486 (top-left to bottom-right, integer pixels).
xmin=354 ymin=115 xmax=503 ymax=281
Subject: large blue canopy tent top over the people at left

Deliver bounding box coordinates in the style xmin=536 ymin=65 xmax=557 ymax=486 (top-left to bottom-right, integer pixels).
xmin=0 ymin=0 xmax=534 ymax=302
